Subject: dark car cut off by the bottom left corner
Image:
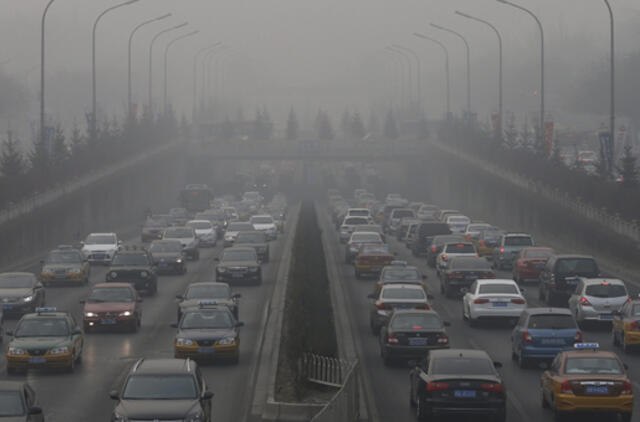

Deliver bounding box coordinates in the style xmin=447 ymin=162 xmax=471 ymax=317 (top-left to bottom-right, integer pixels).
xmin=0 ymin=381 xmax=44 ymax=422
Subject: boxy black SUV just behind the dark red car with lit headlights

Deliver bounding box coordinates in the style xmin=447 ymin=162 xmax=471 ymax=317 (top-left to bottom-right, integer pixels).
xmin=106 ymin=249 xmax=158 ymax=295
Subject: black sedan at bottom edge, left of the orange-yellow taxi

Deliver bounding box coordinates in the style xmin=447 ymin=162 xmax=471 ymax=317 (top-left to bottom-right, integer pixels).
xmin=409 ymin=349 xmax=507 ymax=422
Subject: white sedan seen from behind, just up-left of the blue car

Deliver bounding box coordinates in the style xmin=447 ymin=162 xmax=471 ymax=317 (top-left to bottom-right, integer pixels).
xmin=462 ymin=279 xmax=527 ymax=325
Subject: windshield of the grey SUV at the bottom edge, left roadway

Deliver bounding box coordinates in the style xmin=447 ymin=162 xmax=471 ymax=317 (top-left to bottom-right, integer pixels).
xmin=122 ymin=375 xmax=198 ymax=400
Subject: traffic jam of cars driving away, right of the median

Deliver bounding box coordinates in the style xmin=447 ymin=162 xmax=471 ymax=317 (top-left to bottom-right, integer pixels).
xmin=327 ymin=189 xmax=640 ymax=422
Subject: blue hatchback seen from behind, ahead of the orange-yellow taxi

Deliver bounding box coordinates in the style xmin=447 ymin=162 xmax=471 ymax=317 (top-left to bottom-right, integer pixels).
xmin=511 ymin=308 xmax=582 ymax=368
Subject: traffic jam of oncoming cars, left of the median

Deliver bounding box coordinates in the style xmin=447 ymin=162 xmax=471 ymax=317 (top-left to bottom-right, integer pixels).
xmin=0 ymin=184 xmax=287 ymax=422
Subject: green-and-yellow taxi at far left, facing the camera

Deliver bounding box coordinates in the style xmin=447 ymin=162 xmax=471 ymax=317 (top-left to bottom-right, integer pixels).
xmin=7 ymin=308 xmax=84 ymax=374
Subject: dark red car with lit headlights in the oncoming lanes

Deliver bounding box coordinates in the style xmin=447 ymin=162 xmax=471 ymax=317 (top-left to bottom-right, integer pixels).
xmin=80 ymin=283 xmax=142 ymax=332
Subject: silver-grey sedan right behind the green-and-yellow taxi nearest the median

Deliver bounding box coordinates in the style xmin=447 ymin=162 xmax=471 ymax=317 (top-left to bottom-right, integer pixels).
xmin=176 ymin=281 xmax=242 ymax=321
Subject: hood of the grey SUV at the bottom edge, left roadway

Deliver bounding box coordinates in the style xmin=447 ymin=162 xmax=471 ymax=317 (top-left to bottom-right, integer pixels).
xmin=115 ymin=400 xmax=200 ymax=420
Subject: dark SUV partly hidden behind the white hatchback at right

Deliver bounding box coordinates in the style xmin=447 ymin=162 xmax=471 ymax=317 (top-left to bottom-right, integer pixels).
xmin=538 ymin=255 xmax=600 ymax=306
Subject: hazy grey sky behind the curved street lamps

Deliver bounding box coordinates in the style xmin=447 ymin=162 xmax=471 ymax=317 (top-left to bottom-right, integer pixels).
xmin=0 ymin=0 xmax=640 ymax=137
